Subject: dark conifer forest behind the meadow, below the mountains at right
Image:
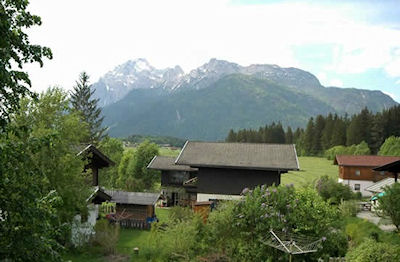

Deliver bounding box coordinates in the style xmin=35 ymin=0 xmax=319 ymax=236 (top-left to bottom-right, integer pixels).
xmin=226 ymin=106 xmax=400 ymax=155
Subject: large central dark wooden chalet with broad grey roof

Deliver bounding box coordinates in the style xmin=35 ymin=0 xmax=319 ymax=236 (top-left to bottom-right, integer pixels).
xmin=175 ymin=141 xmax=299 ymax=201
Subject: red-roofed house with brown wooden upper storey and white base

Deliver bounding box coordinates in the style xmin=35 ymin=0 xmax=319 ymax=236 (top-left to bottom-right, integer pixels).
xmin=334 ymin=155 xmax=400 ymax=196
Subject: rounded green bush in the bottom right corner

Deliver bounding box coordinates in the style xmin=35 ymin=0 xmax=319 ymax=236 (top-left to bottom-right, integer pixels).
xmin=346 ymin=239 xmax=400 ymax=262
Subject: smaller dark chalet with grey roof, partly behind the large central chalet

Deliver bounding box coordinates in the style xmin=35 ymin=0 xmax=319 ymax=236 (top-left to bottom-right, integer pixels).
xmin=147 ymin=156 xmax=198 ymax=206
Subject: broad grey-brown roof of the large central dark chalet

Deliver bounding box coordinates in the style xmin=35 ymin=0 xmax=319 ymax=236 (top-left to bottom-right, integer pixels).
xmin=175 ymin=141 xmax=299 ymax=171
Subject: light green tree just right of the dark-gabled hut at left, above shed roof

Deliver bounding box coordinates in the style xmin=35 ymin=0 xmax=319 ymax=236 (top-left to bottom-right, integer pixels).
xmin=99 ymin=137 xmax=124 ymax=188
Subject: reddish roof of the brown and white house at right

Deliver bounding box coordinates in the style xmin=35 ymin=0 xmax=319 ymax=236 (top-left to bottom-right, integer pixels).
xmin=333 ymin=156 xmax=400 ymax=167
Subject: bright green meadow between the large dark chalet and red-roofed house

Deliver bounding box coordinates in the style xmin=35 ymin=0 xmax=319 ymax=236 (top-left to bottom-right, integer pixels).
xmin=281 ymin=157 xmax=338 ymax=186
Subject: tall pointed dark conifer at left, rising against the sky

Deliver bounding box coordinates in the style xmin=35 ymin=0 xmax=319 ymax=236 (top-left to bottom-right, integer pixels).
xmin=71 ymin=72 xmax=107 ymax=145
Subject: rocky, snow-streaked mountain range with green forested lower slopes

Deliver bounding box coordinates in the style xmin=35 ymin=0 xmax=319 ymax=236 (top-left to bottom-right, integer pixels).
xmin=93 ymin=58 xmax=397 ymax=140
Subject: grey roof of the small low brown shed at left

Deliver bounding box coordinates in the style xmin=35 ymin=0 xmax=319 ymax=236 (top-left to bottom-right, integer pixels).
xmin=105 ymin=190 xmax=160 ymax=206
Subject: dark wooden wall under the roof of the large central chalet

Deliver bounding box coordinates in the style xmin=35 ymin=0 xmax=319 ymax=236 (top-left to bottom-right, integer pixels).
xmin=197 ymin=168 xmax=281 ymax=195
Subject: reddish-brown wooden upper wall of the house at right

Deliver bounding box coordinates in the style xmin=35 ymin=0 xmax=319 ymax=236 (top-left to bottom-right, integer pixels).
xmin=339 ymin=166 xmax=393 ymax=182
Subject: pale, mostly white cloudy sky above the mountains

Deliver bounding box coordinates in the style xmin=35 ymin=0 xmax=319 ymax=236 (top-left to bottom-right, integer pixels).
xmin=24 ymin=0 xmax=400 ymax=102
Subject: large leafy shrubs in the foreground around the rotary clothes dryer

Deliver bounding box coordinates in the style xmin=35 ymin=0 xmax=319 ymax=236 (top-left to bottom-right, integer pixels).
xmin=147 ymin=186 xmax=347 ymax=261
